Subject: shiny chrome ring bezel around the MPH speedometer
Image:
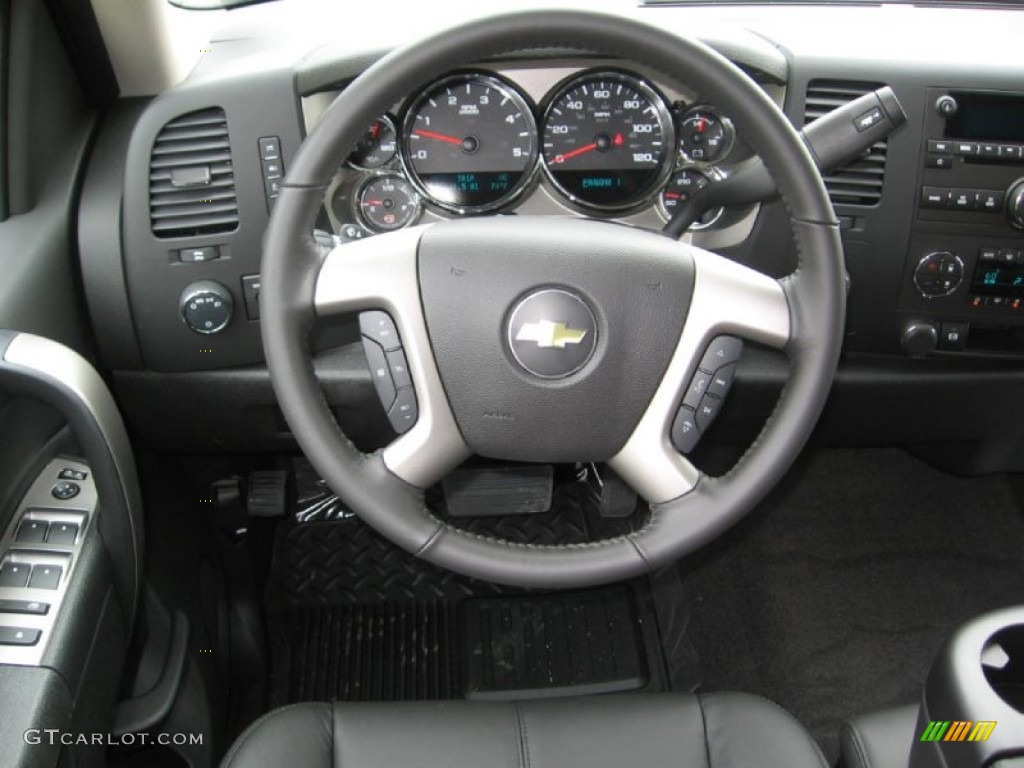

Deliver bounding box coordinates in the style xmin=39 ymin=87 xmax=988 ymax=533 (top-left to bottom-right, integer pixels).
xmin=538 ymin=69 xmax=678 ymax=213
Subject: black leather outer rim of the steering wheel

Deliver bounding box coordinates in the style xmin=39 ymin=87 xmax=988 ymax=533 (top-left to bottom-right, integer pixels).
xmin=260 ymin=11 xmax=846 ymax=588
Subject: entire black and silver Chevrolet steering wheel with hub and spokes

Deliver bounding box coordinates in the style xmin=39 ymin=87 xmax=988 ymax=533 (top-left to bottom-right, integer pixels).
xmin=260 ymin=11 xmax=846 ymax=588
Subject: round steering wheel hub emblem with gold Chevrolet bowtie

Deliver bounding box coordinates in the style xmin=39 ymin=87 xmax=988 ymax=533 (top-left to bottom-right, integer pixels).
xmin=508 ymin=289 xmax=597 ymax=379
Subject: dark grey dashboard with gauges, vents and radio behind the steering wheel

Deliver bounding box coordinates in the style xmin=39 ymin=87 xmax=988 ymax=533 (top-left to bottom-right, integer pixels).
xmin=79 ymin=6 xmax=1024 ymax=469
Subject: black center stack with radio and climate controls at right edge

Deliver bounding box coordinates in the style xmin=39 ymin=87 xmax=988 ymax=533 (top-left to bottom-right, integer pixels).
xmin=899 ymin=88 xmax=1024 ymax=355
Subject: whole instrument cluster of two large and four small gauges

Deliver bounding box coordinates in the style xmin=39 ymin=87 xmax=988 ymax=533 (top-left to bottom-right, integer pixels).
xmin=332 ymin=68 xmax=749 ymax=233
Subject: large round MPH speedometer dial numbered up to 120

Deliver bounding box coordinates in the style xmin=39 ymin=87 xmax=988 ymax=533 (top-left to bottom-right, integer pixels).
xmin=543 ymin=72 xmax=675 ymax=210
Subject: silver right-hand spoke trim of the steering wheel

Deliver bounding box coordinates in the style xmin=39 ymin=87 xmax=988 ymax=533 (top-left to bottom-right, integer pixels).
xmin=608 ymin=243 xmax=791 ymax=504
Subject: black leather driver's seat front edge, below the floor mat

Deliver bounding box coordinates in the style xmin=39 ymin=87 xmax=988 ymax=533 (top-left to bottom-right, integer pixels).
xmin=222 ymin=693 xmax=826 ymax=768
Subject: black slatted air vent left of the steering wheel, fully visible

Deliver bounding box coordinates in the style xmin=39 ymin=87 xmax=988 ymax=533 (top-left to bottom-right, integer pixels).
xmin=150 ymin=109 xmax=239 ymax=238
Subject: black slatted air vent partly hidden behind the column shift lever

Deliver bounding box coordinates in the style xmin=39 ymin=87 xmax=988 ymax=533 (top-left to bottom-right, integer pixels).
xmin=804 ymin=80 xmax=889 ymax=206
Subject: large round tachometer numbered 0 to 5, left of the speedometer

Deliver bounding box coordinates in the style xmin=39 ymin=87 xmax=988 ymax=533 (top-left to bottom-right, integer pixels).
xmin=401 ymin=75 xmax=538 ymax=213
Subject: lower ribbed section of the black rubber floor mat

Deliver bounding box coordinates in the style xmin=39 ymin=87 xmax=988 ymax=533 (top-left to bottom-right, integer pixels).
xmin=270 ymin=586 xmax=656 ymax=707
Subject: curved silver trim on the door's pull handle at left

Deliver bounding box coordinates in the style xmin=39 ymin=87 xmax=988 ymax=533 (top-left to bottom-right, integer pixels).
xmin=4 ymin=334 xmax=142 ymax=610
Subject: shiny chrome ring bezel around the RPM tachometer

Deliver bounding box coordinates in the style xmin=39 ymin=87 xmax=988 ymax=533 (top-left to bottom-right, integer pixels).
xmin=398 ymin=71 xmax=541 ymax=215
